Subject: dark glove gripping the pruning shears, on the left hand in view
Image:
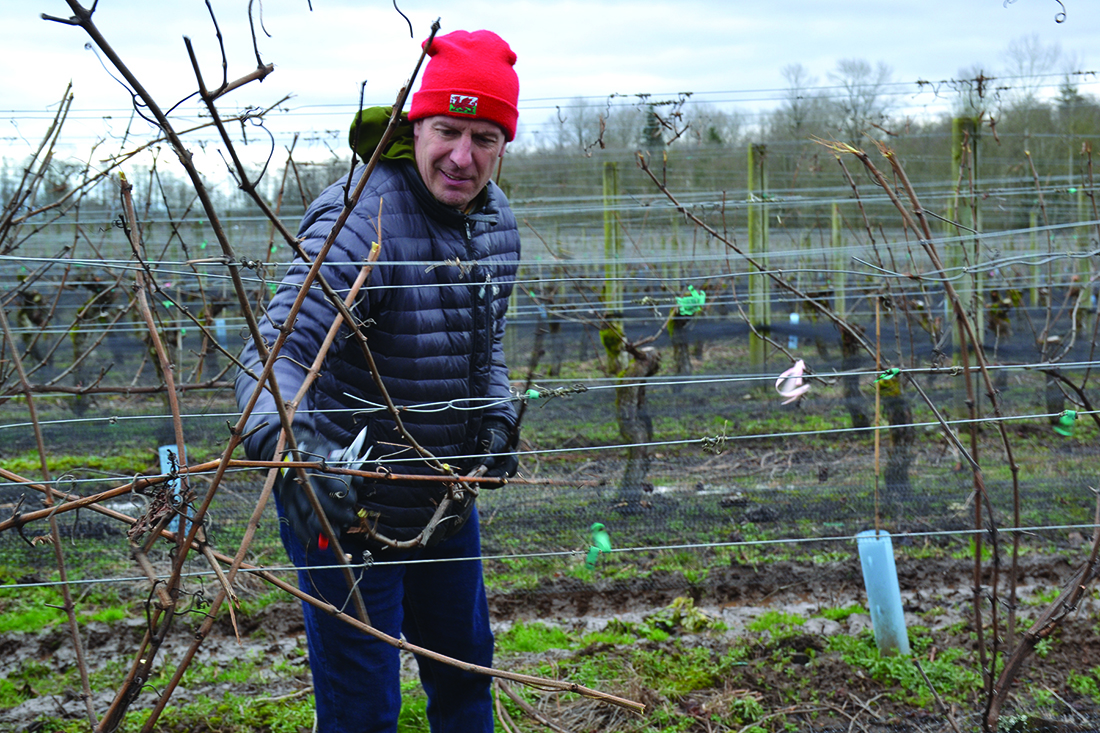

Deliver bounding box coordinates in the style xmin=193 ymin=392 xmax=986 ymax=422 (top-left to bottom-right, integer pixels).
xmin=269 ymin=428 xmax=359 ymax=550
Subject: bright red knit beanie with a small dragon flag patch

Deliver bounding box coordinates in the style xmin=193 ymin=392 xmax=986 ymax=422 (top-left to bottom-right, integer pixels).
xmin=409 ymin=31 xmax=519 ymax=141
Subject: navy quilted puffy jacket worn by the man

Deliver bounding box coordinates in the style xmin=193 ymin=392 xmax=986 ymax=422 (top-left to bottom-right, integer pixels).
xmin=237 ymin=160 xmax=519 ymax=539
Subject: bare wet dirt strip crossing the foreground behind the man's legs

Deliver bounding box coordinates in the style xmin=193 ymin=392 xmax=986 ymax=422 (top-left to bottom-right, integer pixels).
xmin=0 ymin=555 xmax=1100 ymax=731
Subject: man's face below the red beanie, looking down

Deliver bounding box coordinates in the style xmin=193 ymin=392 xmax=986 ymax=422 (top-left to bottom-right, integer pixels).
xmin=413 ymin=114 xmax=505 ymax=209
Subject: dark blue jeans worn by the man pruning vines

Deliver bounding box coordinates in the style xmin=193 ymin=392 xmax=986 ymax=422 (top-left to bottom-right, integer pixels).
xmin=279 ymin=497 xmax=493 ymax=733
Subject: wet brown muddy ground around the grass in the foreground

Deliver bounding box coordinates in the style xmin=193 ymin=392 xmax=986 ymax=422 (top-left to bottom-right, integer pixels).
xmin=0 ymin=547 xmax=1100 ymax=731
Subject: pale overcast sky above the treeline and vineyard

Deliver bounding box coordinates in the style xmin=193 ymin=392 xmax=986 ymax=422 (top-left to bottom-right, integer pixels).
xmin=0 ymin=0 xmax=1100 ymax=157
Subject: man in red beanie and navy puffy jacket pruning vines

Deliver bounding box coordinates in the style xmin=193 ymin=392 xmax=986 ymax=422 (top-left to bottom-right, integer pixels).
xmin=237 ymin=31 xmax=519 ymax=733
